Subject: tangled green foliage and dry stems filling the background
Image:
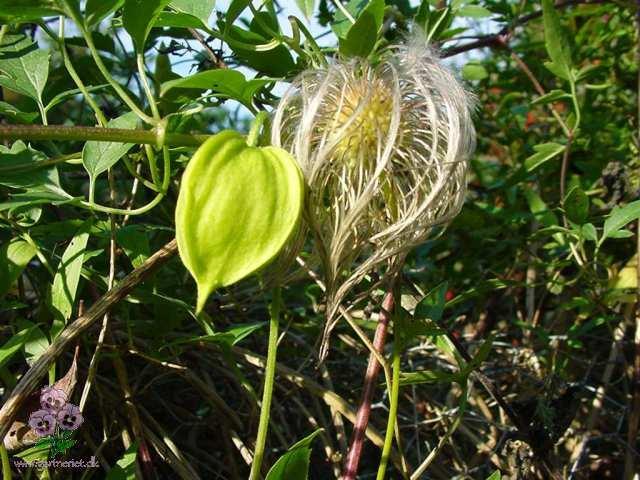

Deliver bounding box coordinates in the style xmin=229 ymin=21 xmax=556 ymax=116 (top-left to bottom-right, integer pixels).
xmin=0 ymin=0 xmax=640 ymax=479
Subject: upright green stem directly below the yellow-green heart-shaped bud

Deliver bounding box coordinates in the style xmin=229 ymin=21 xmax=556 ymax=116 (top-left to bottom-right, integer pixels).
xmin=249 ymin=287 xmax=281 ymax=480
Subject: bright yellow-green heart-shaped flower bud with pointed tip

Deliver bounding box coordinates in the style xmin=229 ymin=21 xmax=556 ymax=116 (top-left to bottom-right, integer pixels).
xmin=176 ymin=131 xmax=304 ymax=312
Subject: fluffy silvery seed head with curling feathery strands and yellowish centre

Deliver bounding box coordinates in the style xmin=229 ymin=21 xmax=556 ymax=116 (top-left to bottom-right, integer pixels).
xmin=272 ymin=42 xmax=475 ymax=356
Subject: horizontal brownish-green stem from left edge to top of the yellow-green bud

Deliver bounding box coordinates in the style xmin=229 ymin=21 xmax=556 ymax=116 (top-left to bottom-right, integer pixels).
xmin=0 ymin=125 xmax=209 ymax=147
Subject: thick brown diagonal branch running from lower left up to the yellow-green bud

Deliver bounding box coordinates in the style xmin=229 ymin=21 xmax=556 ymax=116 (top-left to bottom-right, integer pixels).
xmin=0 ymin=240 xmax=178 ymax=438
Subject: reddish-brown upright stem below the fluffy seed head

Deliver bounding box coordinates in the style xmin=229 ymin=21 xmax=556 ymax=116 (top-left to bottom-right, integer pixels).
xmin=342 ymin=290 xmax=394 ymax=480
